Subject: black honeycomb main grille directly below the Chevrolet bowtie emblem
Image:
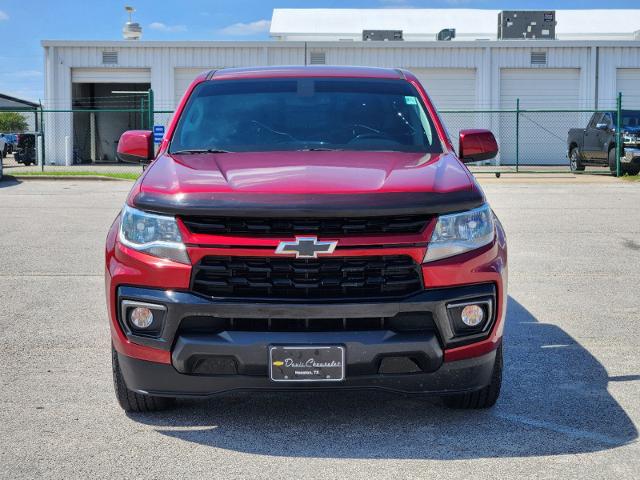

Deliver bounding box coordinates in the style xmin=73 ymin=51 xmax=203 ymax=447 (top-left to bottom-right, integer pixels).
xmin=191 ymin=255 xmax=422 ymax=300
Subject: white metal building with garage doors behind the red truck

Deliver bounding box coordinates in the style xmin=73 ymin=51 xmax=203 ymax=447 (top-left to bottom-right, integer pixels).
xmin=42 ymin=10 xmax=640 ymax=164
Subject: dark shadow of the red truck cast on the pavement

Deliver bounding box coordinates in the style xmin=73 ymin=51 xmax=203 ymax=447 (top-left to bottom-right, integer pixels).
xmin=130 ymin=298 xmax=640 ymax=459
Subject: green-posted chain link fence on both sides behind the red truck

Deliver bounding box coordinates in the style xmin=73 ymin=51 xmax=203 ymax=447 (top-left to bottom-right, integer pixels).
xmin=0 ymin=91 xmax=640 ymax=178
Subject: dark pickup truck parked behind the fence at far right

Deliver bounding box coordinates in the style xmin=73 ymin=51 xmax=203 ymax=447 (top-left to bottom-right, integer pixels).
xmin=567 ymin=110 xmax=640 ymax=175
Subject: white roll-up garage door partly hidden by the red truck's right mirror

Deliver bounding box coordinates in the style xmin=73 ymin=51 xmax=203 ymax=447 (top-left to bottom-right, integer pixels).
xmin=410 ymin=68 xmax=481 ymax=144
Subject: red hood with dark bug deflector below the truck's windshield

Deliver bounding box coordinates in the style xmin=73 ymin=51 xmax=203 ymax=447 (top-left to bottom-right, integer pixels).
xmin=131 ymin=151 xmax=484 ymax=215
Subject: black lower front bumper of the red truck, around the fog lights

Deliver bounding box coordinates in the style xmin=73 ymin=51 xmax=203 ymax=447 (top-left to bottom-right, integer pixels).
xmin=117 ymin=283 xmax=497 ymax=396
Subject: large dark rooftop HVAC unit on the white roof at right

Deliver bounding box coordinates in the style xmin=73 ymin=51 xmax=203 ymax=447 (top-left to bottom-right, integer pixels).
xmin=498 ymin=10 xmax=556 ymax=40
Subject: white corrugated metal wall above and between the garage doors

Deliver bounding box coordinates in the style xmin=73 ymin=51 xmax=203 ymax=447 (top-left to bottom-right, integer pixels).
xmin=43 ymin=41 xmax=640 ymax=162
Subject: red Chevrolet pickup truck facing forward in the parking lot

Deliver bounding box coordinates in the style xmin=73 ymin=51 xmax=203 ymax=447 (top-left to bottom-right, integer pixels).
xmin=106 ymin=67 xmax=507 ymax=411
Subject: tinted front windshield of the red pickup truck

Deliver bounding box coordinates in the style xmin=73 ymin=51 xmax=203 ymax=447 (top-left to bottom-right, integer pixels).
xmin=170 ymin=78 xmax=442 ymax=153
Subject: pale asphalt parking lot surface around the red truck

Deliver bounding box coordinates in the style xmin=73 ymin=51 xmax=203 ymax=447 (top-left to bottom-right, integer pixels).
xmin=0 ymin=177 xmax=640 ymax=479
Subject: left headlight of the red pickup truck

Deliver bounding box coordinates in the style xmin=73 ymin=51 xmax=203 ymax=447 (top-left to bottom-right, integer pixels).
xmin=119 ymin=205 xmax=191 ymax=264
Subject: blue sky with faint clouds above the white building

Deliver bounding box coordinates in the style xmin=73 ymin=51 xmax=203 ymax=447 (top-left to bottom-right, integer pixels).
xmin=0 ymin=0 xmax=633 ymax=100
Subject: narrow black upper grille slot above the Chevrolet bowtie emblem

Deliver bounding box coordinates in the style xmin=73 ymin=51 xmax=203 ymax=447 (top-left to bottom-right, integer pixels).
xmin=181 ymin=215 xmax=431 ymax=236
